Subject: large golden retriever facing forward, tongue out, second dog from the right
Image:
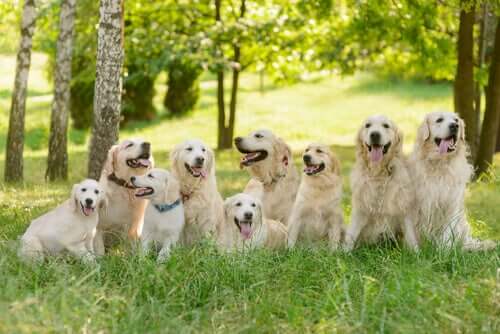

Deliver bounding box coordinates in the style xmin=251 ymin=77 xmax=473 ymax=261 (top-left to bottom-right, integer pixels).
xmin=345 ymin=115 xmax=418 ymax=250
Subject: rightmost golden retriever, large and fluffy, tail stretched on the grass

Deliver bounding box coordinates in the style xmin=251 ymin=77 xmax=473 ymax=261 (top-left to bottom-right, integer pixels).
xmin=411 ymin=112 xmax=496 ymax=250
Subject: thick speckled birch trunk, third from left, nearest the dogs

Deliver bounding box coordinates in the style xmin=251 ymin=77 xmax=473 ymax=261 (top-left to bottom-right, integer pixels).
xmin=88 ymin=0 xmax=123 ymax=179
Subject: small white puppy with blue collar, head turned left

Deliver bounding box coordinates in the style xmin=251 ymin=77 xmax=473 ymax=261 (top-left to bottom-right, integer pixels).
xmin=130 ymin=168 xmax=184 ymax=263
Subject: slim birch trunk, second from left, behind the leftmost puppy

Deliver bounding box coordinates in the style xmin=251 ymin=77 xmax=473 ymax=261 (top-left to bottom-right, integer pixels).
xmin=45 ymin=0 xmax=76 ymax=181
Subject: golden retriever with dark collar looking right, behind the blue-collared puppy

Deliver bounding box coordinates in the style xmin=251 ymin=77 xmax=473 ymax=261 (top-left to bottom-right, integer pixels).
xmin=95 ymin=139 xmax=154 ymax=255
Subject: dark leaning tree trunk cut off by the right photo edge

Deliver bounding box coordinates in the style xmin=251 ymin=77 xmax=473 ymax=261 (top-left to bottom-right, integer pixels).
xmin=477 ymin=23 xmax=500 ymax=175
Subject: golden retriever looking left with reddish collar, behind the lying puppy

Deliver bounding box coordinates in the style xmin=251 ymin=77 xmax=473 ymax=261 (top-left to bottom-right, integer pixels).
xmin=234 ymin=130 xmax=300 ymax=225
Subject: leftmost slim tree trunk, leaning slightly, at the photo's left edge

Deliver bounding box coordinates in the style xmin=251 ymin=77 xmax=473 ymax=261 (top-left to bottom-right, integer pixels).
xmin=5 ymin=0 xmax=36 ymax=182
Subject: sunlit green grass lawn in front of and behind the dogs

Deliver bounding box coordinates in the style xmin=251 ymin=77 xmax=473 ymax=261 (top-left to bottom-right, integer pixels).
xmin=0 ymin=54 xmax=500 ymax=333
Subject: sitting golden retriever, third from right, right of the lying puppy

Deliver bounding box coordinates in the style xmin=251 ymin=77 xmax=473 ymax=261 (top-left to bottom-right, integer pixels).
xmin=288 ymin=144 xmax=344 ymax=249
